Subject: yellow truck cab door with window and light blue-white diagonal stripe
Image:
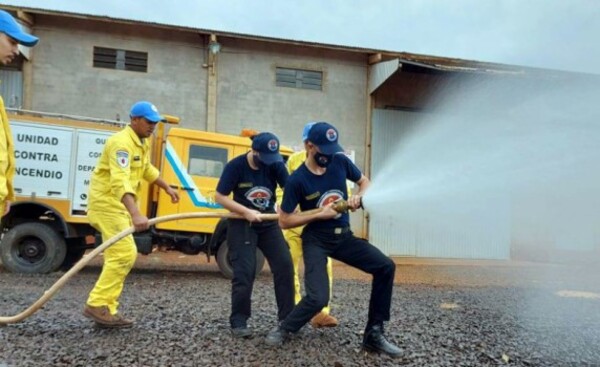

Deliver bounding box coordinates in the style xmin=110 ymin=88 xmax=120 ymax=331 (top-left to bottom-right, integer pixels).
xmin=157 ymin=137 xmax=233 ymax=233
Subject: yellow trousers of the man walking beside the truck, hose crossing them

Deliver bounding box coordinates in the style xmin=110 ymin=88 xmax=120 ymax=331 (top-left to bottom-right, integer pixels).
xmin=87 ymin=211 xmax=137 ymax=315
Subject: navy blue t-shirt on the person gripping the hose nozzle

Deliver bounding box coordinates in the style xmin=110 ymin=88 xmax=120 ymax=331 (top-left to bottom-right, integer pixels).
xmin=281 ymin=154 xmax=362 ymax=229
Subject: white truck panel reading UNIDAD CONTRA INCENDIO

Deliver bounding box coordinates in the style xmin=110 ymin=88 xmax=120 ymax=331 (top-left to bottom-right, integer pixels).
xmin=11 ymin=121 xmax=73 ymax=199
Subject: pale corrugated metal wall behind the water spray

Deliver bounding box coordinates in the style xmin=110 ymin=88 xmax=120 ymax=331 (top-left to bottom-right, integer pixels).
xmin=369 ymin=109 xmax=510 ymax=259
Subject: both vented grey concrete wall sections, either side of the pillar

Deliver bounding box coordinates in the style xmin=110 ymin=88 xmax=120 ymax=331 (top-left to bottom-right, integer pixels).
xmin=31 ymin=15 xmax=367 ymax=168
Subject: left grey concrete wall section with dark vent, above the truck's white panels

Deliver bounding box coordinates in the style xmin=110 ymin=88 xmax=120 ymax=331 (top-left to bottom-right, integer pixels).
xmin=31 ymin=15 xmax=207 ymax=129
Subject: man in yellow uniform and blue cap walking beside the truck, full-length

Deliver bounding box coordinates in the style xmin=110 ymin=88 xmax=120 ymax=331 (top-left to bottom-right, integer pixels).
xmin=83 ymin=101 xmax=179 ymax=328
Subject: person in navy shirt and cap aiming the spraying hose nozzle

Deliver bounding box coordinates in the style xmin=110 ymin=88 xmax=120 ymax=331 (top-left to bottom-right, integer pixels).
xmin=266 ymin=122 xmax=402 ymax=357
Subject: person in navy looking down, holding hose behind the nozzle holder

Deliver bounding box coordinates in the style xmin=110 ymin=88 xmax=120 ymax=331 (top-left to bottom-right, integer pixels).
xmin=215 ymin=132 xmax=294 ymax=338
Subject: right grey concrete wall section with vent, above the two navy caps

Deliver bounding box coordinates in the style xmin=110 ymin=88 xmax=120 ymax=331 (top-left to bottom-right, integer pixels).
xmin=217 ymin=38 xmax=367 ymax=168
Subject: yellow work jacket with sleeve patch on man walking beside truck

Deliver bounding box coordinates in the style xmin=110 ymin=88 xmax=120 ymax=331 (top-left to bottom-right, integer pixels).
xmin=88 ymin=126 xmax=159 ymax=213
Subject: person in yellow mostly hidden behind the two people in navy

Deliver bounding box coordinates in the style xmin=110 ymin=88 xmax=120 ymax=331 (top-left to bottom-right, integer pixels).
xmin=277 ymin=122 xmax=338 ymax=328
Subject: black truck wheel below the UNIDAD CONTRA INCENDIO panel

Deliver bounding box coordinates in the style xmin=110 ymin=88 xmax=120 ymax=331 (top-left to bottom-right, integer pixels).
xmin=0 ymin=223 xmax=67 ymax=273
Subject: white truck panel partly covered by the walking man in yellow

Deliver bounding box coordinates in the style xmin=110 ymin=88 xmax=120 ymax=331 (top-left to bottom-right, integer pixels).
xmin=71 ymin=131 xmax=112 ymax=211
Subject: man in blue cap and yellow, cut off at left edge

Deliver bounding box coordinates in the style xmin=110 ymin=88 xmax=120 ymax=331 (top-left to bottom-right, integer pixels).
xmin=0 ymin=10 xmax=39 ymax=216
